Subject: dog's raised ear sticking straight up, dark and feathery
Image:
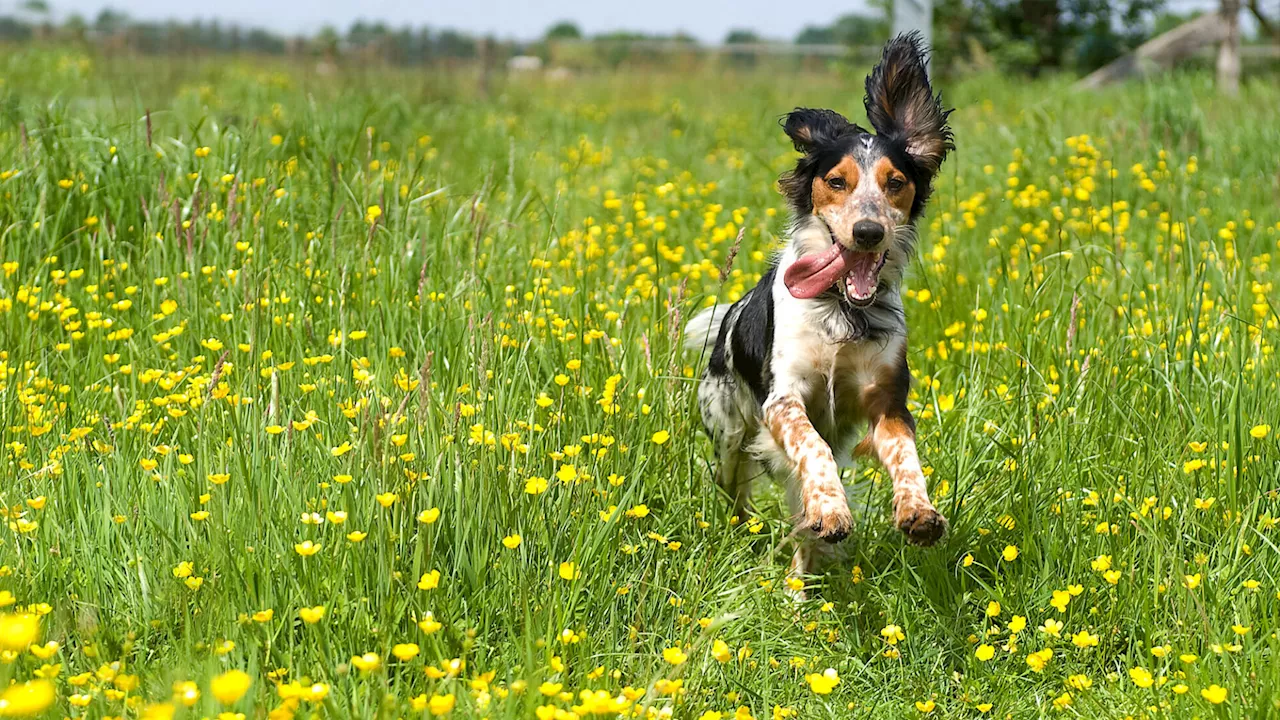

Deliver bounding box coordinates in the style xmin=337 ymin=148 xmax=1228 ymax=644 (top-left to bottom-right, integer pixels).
xmin=863 ymin=32 xmax=955 ymax=176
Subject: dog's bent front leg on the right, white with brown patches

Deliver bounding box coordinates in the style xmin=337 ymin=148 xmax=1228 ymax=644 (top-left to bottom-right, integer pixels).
xmin=858 ymin=404 xmax=947 ymax=544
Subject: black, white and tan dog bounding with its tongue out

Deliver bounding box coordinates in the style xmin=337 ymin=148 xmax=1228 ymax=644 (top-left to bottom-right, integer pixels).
xmin=685 ymin=33 xmax=955 ymax=575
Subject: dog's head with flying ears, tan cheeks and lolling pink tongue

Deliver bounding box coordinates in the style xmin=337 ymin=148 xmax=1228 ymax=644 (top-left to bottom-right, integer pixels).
xmin=780 ymin=33 xmax=955 ymax=305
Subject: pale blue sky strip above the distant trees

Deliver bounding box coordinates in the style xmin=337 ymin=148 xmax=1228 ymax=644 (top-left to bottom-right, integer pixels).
xmin=32 ymin=0 xmax=867 ymax=42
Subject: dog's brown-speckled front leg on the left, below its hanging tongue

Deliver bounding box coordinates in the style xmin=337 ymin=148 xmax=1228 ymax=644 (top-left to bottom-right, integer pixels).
xmin=764 ymin=393 xmax=854 ymax=540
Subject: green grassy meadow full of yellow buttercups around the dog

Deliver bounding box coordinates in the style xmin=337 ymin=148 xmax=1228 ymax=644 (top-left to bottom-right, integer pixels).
xmin=0 ymin=47 xmax=1280 ymax=720
